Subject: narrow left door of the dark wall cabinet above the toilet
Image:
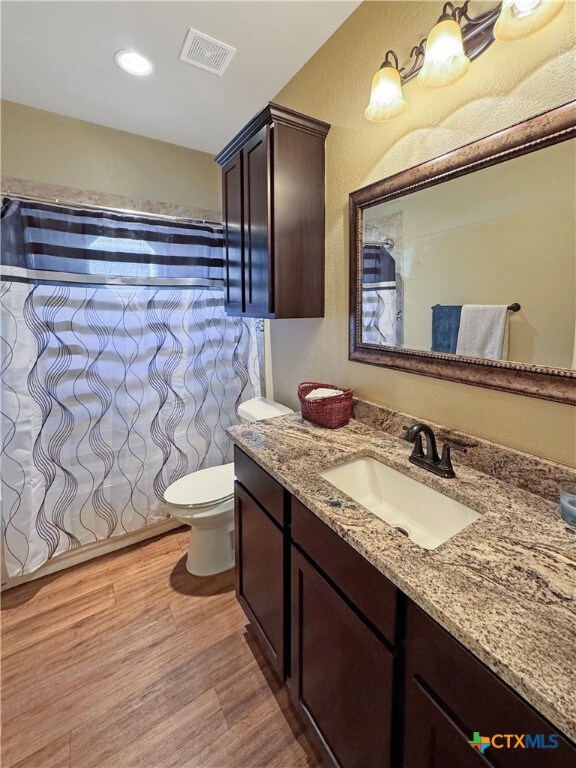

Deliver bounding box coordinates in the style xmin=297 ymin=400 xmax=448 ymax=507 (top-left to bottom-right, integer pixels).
xmin=222 ymin=152 xmax=244 ymax=315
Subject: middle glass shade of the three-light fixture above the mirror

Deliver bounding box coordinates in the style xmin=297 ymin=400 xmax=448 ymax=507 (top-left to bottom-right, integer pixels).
xmin=418 ymin=19 xmax=470 ymax=88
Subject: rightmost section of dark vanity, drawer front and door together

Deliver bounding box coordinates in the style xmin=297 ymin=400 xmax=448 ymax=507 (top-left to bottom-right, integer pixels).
xmin=403 ymin=602 xmax=576 ymax=768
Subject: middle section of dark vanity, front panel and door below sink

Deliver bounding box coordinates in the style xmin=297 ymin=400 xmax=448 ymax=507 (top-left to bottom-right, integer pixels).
xmin=289 ymin=499 xmax=397 ymax=768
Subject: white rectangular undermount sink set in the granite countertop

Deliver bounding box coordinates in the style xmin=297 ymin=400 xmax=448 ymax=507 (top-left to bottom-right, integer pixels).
xmin=320 ymin=456 xmax=480 ymax=549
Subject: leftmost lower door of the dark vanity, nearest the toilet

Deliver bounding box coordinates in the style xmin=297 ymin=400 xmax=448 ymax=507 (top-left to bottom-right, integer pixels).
xmin=234 ymin=483 xmax=286 ymax=680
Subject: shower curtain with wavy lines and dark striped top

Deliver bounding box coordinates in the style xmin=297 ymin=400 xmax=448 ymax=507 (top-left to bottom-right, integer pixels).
xmin=0 ymin=200 xmax=260 ymax=576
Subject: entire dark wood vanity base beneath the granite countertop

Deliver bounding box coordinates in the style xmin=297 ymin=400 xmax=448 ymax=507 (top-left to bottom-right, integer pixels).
xmin=235 ymin=448 xmax=576 ymax=768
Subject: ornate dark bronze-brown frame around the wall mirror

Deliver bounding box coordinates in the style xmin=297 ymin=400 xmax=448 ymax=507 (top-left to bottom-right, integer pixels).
xmin=349 ymin=101 xmax=576 ymax=405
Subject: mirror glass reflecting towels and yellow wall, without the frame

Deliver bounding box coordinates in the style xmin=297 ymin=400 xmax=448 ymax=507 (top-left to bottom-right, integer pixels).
xmin=361 ymin=140 xmax=576 ymax=369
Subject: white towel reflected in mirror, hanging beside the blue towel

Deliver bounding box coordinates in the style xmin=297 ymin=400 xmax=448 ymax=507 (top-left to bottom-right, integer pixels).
xmin=456 ymin=304 xmax=508 ymax=360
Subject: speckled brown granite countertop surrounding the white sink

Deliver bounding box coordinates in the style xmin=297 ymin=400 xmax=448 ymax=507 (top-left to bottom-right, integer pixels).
xmin=228 ymin=414 xmax=576 ymax=741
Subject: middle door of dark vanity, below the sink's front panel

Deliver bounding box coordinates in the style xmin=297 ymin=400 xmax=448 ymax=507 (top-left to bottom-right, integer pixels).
xmin=290 ymin=546 xmax=394 ymax=768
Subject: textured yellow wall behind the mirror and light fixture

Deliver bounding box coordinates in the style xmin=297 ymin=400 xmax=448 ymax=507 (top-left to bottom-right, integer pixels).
xmin=271 ymin=2 xmax=576 ymax=464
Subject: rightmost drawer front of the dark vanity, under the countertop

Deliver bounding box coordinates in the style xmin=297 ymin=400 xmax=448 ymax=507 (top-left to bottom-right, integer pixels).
xmin=406 ymin=602 xmax=576 ymax=768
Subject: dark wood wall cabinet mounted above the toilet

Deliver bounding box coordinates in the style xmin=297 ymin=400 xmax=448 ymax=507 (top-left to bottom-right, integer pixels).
xmin=216 ymin=104 xmax=330 ymax=318
